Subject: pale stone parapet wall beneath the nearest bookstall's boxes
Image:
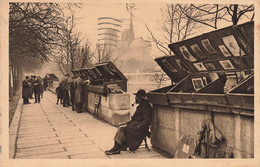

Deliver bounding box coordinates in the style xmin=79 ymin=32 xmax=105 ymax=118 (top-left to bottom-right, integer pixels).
xmin=151 ymin=104 xmax=254 ymax=158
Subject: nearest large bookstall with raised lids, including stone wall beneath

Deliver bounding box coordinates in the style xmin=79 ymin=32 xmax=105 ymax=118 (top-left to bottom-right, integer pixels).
xmin=148 ymin=22 xmax=254 ymax=158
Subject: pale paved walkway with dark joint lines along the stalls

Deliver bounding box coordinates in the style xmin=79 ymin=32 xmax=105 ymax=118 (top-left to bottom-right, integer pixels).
xmin=9 ymin=91 xmax=166 ymax=159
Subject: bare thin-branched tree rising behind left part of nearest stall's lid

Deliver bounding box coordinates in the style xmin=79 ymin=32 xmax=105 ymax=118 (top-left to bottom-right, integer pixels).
xmin=145 ymin=4 xmax=196 ymax=55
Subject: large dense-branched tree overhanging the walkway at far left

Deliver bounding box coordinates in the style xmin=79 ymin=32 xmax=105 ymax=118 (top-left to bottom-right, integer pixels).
xmin=9 ymin=2 xmax=64 ymax=96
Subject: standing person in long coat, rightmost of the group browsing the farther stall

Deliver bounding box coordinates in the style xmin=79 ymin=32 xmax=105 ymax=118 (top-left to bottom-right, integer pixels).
xmin=74 ymin=75 xmax=89 ymax=113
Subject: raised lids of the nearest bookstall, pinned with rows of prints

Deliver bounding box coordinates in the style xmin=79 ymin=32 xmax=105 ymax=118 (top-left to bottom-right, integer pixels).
xmin=155 ymin=22 xmax=254 ymax=83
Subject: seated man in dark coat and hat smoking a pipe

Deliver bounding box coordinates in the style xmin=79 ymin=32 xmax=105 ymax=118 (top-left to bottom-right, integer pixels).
xmin=105 ymin=89 xmax=152 ymax=155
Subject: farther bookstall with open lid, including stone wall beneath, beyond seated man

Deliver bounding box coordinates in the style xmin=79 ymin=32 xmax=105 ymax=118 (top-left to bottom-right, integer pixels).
xmin=72 ymin=61 xmax=130 ymax=125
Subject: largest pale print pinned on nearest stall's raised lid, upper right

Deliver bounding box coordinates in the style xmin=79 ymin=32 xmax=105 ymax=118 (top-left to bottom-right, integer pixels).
xmin=222 ymin=35 xmax=245 ymax=56
